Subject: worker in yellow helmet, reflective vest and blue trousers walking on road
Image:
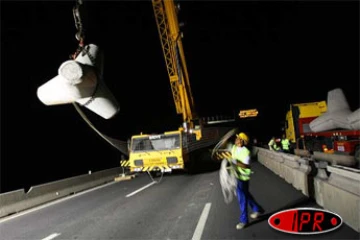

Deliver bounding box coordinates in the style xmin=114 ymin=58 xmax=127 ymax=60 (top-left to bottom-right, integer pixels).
xmin=231 ymin=133 xmax=264 ymax=229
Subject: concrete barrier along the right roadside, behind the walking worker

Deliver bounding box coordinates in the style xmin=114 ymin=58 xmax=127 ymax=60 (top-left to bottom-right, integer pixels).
xmin=252 ymin=148 xmax=360 ymax=232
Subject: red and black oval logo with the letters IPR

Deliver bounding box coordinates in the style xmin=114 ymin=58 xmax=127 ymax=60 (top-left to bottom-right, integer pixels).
xmin=268 ymin=208 xmax=343 ymax=235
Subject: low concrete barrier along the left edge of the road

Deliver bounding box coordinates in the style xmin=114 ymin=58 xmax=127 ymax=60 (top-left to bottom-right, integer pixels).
xmin=0 ymin=168 xmax=122 ymax=217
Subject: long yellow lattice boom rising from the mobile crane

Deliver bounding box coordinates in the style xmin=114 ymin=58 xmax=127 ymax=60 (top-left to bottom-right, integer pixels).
xmin=152 ymin=0 xmax=196 ymax=127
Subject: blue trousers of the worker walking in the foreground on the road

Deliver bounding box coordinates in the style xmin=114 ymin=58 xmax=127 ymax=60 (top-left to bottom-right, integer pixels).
xmin=236 ymin=179 xmax=263 ymax=224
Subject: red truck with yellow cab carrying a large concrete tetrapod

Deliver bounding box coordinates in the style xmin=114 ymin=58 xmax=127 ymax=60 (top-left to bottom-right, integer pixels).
xmin=284 ymin=89 xmax=360 ymax=166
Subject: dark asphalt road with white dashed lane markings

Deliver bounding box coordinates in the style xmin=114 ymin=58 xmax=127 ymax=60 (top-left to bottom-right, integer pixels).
xmin=0 ymin=158 xmax=360 ymax=240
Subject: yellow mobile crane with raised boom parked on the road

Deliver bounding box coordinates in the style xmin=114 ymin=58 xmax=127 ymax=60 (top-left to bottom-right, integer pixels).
xmin=128 ymin=0 xmax=219 ymax=172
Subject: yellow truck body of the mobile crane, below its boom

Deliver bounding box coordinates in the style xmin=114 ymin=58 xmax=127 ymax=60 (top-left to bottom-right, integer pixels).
xmin=127 ymin=126 xmax=225 ymax=173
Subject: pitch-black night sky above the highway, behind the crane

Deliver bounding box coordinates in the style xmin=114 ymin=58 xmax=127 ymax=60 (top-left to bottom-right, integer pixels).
xmin=0 ymin=1 xmax=360 ymax=192
